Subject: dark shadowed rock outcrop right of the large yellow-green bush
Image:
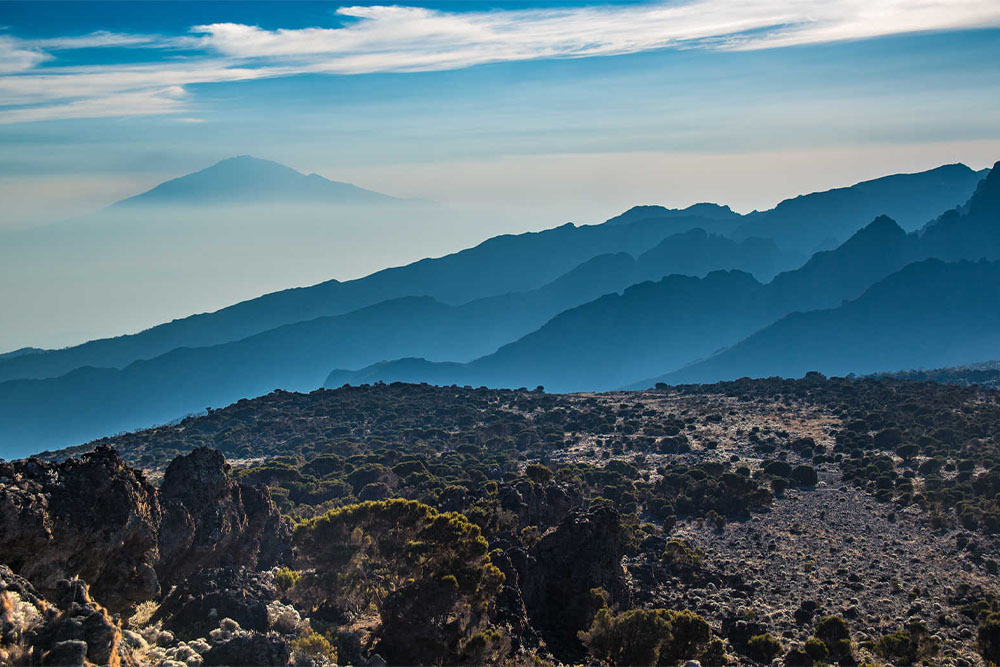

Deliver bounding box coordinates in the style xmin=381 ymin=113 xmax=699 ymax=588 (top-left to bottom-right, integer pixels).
xmin=508 ymin=506 xmax=629 ymax=660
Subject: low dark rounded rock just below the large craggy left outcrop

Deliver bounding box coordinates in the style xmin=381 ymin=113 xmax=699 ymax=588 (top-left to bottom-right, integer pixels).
xmin=152 ymin=568 xmax=278 ymax=639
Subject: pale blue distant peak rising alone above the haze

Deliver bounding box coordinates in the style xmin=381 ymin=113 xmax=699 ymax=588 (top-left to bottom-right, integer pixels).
xmin=112 ymin=155 xmax=401 ymax=208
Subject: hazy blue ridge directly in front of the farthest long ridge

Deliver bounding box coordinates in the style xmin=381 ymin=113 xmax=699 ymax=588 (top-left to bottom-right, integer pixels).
xmin=0 ymin=230 xmax=796 ymax=451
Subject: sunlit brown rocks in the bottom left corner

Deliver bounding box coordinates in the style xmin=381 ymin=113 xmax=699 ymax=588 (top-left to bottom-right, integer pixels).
xmin=0 ymin=566 xmax=133 ymax=667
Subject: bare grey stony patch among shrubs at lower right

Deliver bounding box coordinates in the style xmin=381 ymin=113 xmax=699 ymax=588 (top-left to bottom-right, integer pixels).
xmin=668 ymin=473 xmax=997 ymax=665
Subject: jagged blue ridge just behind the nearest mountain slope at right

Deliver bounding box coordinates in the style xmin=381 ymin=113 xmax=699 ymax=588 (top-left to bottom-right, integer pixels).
xmin=327 ymin=160 xmax=1000 ymax=391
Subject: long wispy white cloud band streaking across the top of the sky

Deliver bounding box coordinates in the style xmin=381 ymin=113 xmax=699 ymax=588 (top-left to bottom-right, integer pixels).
xmin=0 ymin=0 xmax=1000 ymax=123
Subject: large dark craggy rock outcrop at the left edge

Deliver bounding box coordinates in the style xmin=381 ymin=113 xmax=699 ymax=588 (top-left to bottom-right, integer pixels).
xmin=0 ymin=447 xmax=291 ymax=613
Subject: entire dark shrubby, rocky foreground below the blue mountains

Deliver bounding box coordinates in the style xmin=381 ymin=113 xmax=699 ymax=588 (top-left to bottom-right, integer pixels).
xmin=0 ymin=375 xmax=1000 ymax=667
